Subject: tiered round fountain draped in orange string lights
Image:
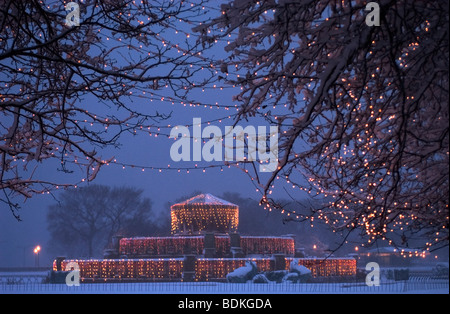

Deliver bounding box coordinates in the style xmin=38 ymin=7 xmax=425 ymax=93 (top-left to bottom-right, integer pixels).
xmin=53 ymin=194 xmax=356 ymax=282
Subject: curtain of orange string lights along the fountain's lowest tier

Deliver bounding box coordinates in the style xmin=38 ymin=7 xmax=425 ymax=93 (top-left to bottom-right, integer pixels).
xmin=53 ymin=258 xmax=356 ymax=282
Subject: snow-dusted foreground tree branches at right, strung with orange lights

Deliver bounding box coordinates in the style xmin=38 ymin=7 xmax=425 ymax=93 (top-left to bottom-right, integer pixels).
xmin=195 ymin=0 xmax=449 ymax=251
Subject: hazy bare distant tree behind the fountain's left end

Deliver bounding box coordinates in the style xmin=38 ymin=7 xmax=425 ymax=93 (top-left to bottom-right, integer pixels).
xmin=47 ymin=185 xmax=159 ymax=257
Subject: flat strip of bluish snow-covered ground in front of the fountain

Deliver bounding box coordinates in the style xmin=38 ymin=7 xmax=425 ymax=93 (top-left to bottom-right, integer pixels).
xmin=0 ymin=280 xmax=449 ymax=294
